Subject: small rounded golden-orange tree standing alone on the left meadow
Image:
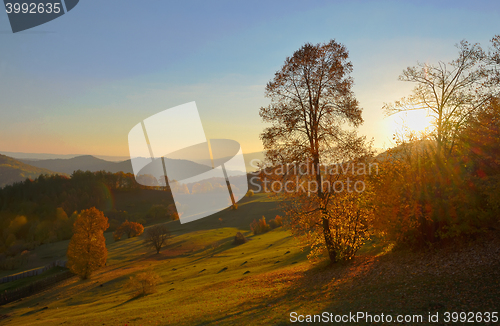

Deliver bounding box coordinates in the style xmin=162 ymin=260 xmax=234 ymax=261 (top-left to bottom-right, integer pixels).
xmin=67 ymin=207 xmax=109 ymax=279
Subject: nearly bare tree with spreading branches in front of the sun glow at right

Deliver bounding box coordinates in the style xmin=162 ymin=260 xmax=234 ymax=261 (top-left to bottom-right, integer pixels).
xmin=383 ymin=39 xmax=499 ymax=154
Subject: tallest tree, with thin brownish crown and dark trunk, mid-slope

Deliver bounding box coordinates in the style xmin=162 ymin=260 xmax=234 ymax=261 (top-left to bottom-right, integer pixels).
xmin=260 ymin=40 xmax=370 ymax=262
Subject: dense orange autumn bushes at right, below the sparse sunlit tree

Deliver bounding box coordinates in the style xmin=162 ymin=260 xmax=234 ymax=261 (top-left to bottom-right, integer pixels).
xmin=372 ymin=100 xmax=500 ymax=247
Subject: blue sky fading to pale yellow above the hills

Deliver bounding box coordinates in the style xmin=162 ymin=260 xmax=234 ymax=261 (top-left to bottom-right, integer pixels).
xmin=0 ymin=0 xmax=500 ymax=156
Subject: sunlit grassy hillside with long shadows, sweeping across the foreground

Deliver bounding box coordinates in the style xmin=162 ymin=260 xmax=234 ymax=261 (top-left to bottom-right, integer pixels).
xmin=0 ymin=195 xmax=500 ymax=325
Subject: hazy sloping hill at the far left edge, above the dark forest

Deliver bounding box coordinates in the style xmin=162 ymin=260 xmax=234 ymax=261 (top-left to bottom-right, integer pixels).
xmin=0 ymin=154 xmax=62 ymax=188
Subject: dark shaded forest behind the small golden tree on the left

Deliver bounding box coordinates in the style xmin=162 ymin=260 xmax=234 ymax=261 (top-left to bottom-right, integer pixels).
xmin=0 ymin=171 xmax=175 ymax=269
